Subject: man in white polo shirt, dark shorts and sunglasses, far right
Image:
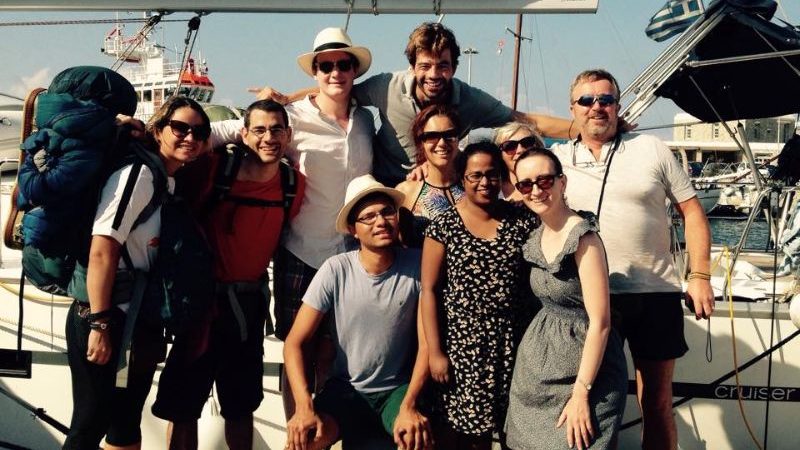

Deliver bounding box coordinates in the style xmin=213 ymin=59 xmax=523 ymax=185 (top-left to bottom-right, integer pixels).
xmin=553 ymin=69 xmax=714 ymax=449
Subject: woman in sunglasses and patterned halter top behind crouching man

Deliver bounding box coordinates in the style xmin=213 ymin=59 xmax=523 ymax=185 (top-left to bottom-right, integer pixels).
xmin=397 ymin=105 xmax=464 ymax=248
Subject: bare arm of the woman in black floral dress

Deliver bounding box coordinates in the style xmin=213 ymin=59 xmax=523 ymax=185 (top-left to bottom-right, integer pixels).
xmin=420 ymin=237 xmax=449 ymax=383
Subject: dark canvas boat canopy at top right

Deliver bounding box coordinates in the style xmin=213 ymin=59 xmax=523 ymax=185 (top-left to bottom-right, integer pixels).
xmin=656 ymin=0 xmax=800 ymax=122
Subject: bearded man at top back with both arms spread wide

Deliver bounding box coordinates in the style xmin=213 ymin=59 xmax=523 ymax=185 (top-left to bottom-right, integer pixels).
xmin=259 ymin=22 xmax=570 ymax=186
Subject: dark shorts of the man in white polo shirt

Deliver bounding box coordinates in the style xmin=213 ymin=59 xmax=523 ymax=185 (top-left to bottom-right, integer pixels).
xmin=611 ymin=292 xmax=689 ymax=361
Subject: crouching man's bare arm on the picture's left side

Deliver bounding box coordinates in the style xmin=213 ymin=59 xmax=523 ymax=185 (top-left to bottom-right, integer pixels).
xmin=283 ymin=304 xmax=323 ymax=449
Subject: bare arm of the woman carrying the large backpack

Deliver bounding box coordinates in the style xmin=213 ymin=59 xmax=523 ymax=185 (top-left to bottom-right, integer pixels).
xmin=86 ymin=236 xmax=122 ymax=365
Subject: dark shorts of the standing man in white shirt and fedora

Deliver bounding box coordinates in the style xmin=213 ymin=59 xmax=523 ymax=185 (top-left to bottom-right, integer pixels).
xmin=272 ymin=247 xmax=328 ymax=341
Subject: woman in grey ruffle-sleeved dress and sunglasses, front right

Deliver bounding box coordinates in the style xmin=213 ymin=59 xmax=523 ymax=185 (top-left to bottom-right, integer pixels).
xmin=506 ymin=150 xmax=628 ymax=450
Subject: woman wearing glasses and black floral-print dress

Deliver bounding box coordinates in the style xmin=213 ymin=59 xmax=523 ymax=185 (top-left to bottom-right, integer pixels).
xmin=421 ymin=141 xmax=536 ymax=449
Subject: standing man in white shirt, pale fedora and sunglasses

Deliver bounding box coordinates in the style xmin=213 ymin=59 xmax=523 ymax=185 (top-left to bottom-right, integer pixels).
xmin=211 ymin=28 xmax=375 ymax=418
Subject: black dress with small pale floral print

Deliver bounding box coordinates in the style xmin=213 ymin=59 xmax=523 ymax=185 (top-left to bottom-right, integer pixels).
xmin=425 ymin=202 xmax=536 ymax=436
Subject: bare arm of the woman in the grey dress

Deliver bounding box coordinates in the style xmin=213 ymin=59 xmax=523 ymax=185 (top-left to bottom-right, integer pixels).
xmin=558 ymin=233 xmax=611 ymax=449
